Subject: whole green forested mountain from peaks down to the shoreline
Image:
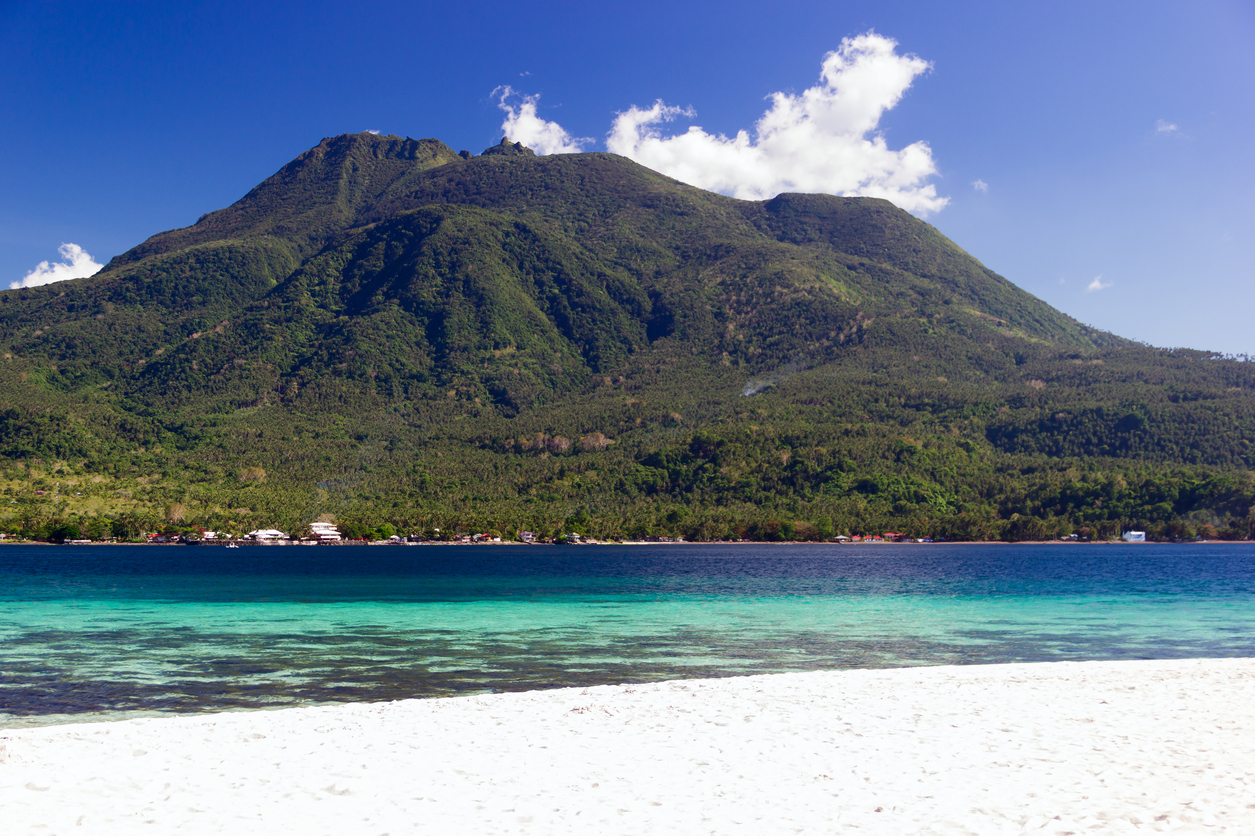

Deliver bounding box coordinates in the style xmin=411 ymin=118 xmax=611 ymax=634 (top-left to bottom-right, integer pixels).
xmin=0 ymin=134 xmax=1255 ymax=540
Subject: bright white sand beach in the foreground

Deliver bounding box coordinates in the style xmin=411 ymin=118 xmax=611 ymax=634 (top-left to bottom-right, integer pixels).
xmin=0 ymin=659 xmax=1255 ymax=835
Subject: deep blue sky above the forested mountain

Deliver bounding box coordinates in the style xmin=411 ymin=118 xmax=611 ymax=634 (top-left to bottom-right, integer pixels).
xmin=0 ymin=0 xmax=1255 ymax=354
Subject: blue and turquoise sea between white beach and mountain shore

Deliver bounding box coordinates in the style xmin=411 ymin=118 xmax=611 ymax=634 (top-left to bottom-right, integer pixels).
xmin=0 ymin=544 xmax=1255 ymax=727
